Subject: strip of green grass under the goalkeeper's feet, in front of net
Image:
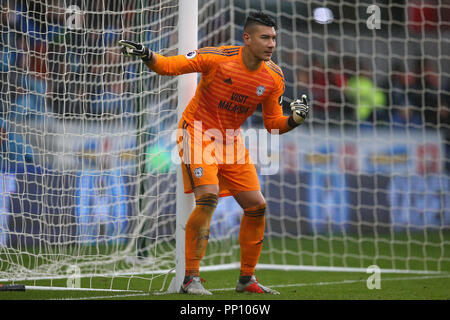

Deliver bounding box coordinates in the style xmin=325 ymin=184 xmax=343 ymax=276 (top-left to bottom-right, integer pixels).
xmin=0 ymin=270 xmax=450 ymax=300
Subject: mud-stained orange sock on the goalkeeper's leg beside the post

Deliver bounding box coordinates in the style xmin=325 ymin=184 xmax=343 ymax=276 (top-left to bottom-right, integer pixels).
xmin=185 ymin=193 xmax=218 ymax=276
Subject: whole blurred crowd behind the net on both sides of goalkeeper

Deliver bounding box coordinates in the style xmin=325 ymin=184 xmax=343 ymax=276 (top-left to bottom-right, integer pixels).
xmin=0 ymin=0 xmax=450 ymax=172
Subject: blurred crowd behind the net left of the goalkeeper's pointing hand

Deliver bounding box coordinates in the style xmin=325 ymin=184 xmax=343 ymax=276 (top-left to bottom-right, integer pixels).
xmin=0 ymin=0 xmax=141 ymax=121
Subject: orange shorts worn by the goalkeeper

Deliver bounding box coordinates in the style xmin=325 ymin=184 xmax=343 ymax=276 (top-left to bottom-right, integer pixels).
xmin=177 ymin=119 xmax=261 ymax=197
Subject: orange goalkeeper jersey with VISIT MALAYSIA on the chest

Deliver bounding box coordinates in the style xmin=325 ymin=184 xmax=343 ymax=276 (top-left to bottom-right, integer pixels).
xmin=151 ymin=46 xmax=290 ymax=141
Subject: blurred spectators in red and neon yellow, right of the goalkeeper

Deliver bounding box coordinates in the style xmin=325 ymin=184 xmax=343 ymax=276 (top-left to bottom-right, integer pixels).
xmin=296 ymin=49 xmax=450 ymax=129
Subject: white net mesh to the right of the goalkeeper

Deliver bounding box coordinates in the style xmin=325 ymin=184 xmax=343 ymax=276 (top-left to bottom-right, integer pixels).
xmin=227 ymin=0 xmax=450 ymax=271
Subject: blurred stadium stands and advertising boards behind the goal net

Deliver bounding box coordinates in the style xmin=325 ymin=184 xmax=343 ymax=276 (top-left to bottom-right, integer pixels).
xmin=0 ymin=0 xmax=450 ymax=269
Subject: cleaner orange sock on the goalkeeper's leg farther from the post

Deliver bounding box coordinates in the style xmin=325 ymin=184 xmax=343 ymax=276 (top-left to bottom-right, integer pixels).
xmin=239 ymin=204 xmax=266 ymax=276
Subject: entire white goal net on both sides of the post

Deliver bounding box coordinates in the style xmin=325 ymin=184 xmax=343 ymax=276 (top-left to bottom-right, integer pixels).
xmin=0 ymin=0 xmax=450 ymax=290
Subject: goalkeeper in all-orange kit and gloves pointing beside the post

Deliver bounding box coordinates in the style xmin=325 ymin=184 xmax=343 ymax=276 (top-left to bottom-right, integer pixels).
xmin=119 ymin=12 xmax=309 ymax=294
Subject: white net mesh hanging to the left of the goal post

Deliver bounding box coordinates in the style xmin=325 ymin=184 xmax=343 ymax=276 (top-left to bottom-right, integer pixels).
xmin=0 ymin=0 xmax=183 ymax=279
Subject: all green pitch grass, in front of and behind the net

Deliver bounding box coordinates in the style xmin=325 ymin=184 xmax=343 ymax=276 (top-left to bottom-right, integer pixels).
xmin=0 ymin=233 xmax=450 ymax=301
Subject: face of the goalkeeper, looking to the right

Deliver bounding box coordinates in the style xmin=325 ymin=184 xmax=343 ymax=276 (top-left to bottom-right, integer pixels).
xmin=244 ymin=25 xmax=277 ymax=61
